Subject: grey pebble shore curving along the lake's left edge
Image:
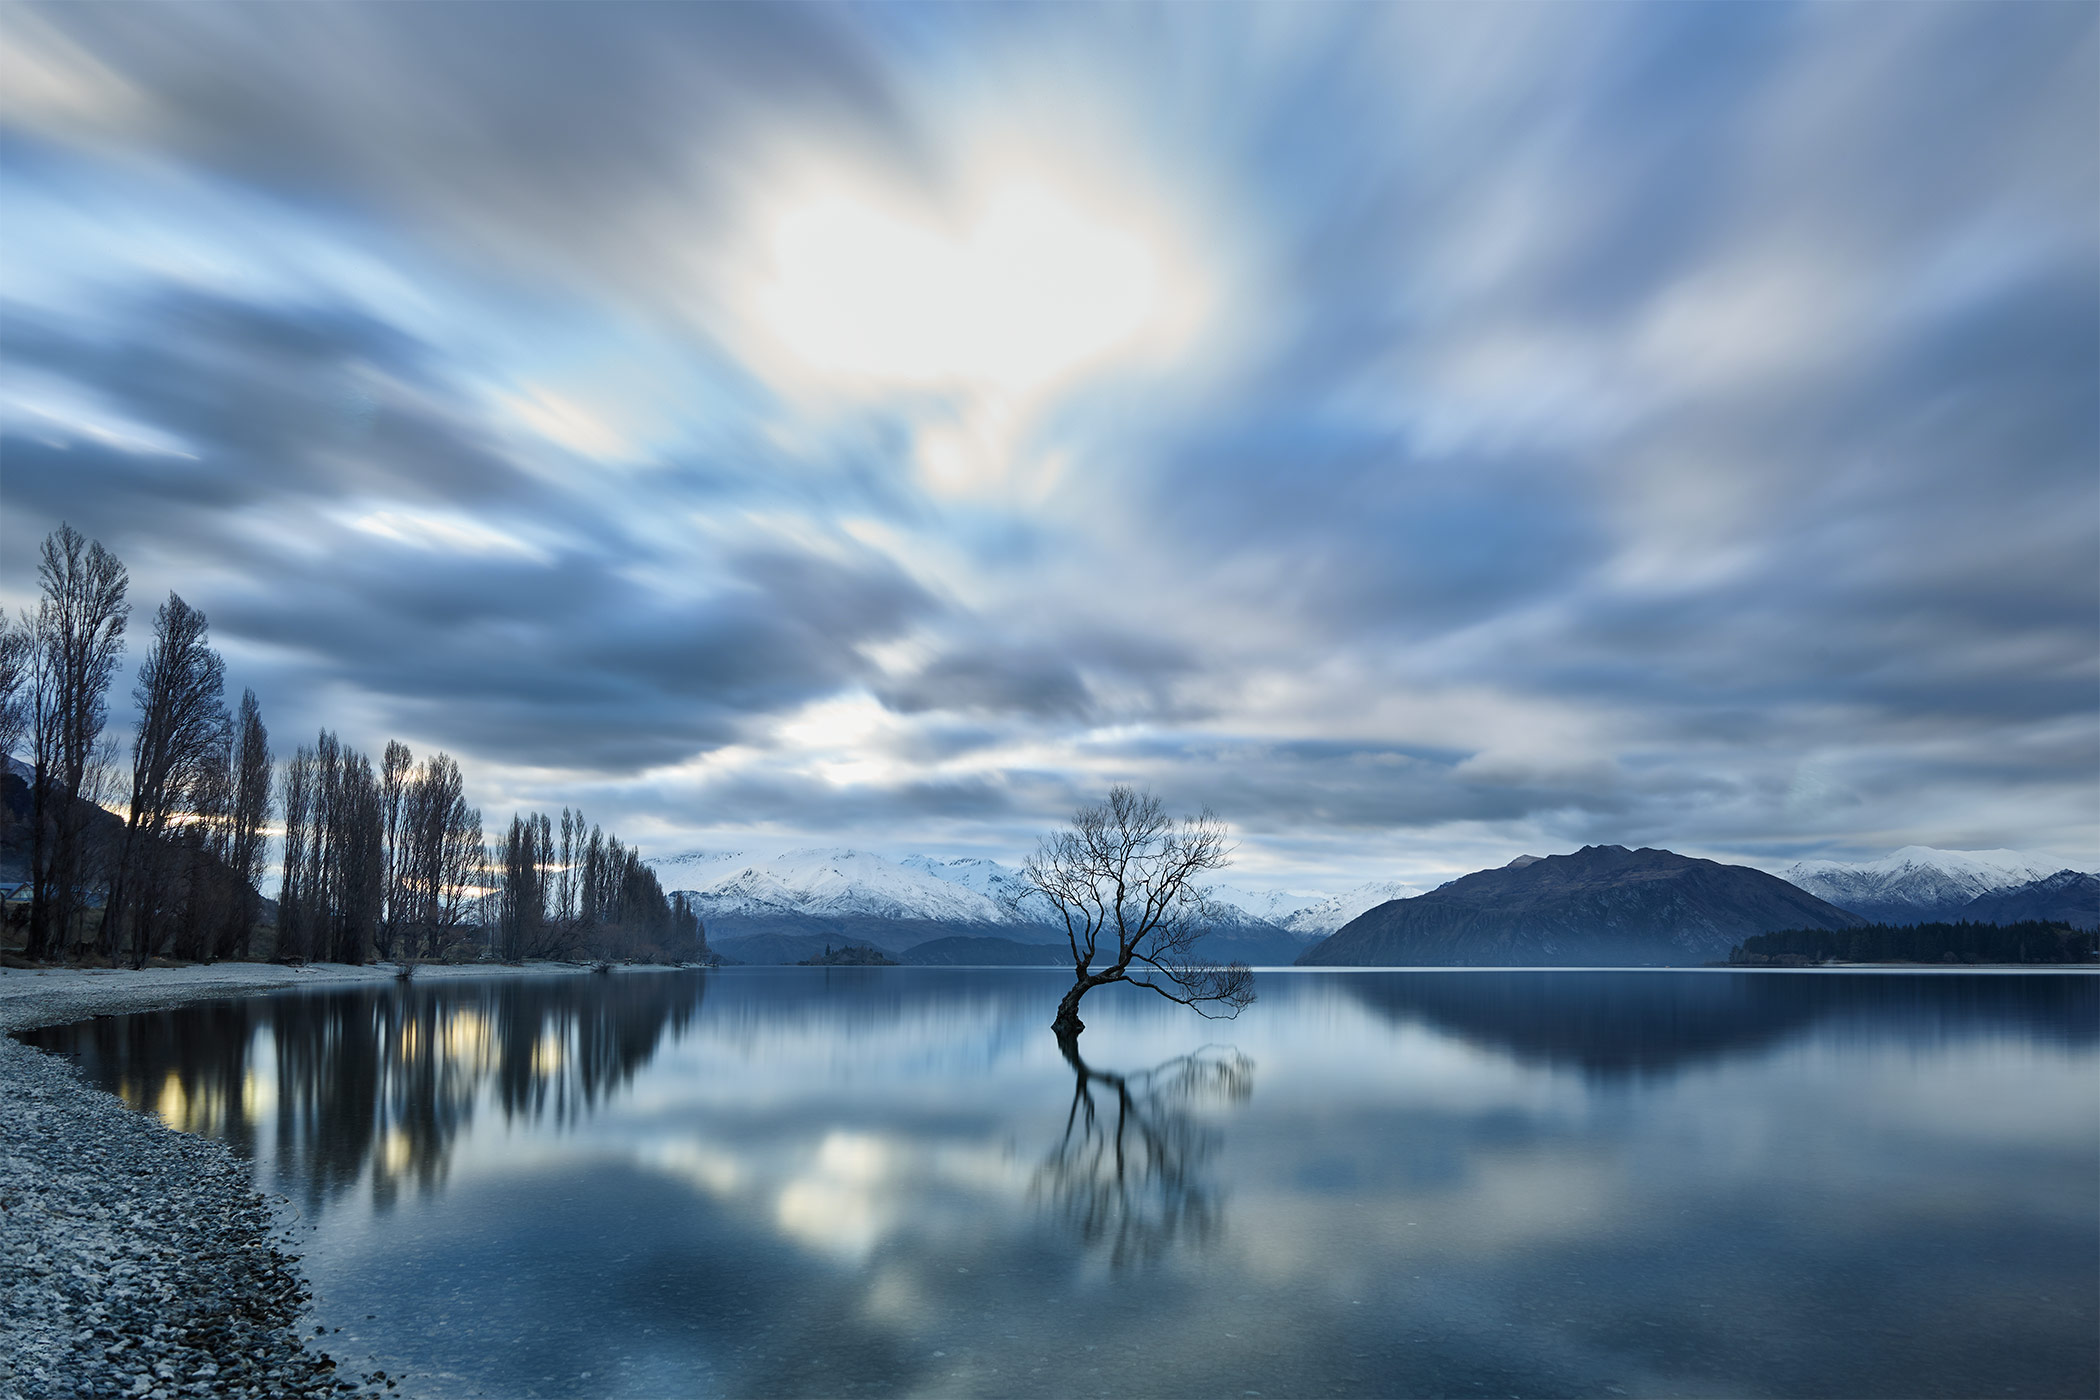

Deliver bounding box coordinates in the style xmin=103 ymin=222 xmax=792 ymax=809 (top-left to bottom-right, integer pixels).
xmin=0 ymin=963 xmax=609 ymax=1400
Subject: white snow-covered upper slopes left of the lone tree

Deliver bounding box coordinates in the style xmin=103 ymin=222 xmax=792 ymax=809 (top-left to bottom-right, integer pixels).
xmin=657 ymin=848 xmax=1016 ymax=924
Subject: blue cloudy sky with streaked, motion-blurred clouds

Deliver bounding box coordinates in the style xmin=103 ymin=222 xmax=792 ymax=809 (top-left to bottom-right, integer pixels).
xmin=0 ymin=4 xmax=2100 ymax=890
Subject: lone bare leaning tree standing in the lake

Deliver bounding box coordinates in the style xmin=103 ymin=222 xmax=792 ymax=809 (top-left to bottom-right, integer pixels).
xmin=1021 ymin=787 xmax=1254 ymax=1049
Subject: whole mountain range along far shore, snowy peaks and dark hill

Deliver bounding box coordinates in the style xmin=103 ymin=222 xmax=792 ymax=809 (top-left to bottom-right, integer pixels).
xmin=653 ymin=846 xmax=2100 ymax=966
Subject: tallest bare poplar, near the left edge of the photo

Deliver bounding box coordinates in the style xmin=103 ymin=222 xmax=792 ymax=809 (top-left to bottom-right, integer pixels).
xmin=27 ymin=525 xmax=130 ymax=959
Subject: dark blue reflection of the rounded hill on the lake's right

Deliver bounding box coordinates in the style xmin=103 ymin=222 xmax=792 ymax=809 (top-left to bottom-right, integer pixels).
xmin=1342 ymin=972 xmax=2100 ymax=1075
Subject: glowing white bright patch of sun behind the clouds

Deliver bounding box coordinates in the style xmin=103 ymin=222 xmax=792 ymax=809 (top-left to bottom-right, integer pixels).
xmin=760 ymin=183 xmax=1161 ymax=393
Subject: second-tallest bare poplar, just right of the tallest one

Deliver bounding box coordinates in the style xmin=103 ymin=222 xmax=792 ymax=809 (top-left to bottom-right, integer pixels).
xmin=103 ymin=594 xmax=227 ymax=966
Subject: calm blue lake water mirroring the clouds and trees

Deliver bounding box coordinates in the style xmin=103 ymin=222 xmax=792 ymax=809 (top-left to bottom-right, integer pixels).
xmin=20 ymin=968 xmax=2100 ymax=1396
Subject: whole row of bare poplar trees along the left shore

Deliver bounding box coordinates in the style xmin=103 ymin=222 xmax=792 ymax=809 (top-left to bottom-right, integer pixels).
xmin=0 ymin=525 xmax=706 ymax=966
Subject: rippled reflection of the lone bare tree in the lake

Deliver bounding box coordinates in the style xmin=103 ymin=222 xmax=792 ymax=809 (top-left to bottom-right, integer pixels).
xmin=1033 ymin=1043 xmax=1254 ymax=1268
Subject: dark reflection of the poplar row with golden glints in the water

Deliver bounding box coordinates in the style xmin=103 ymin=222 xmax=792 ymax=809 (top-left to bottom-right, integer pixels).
xmin=23 ymin=974 xmax=706 ymax=1209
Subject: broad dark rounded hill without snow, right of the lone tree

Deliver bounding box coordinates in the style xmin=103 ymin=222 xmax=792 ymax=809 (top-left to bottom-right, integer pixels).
xmin=1298 ymin=846 xmax=1865 ymax=968
